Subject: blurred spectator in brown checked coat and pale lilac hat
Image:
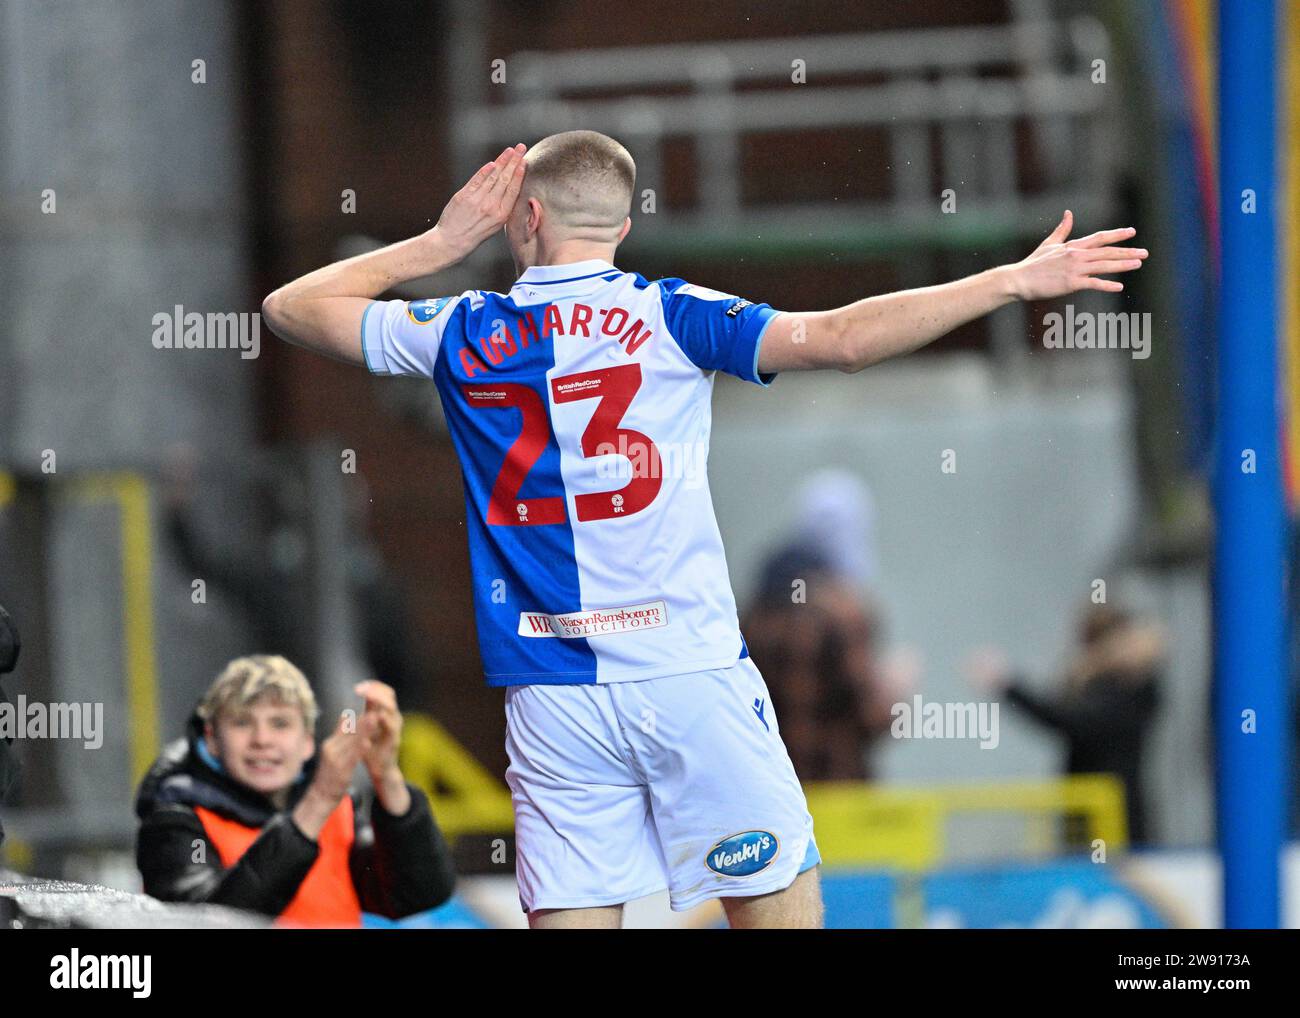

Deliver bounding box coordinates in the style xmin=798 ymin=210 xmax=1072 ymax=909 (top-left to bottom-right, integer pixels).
xmin=741 ymin=471 xmax=898 ymax=781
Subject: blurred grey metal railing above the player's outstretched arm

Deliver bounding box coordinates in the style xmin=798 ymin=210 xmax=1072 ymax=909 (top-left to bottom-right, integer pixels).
xmin=451 ymin=17 xmax=1113 ymax=257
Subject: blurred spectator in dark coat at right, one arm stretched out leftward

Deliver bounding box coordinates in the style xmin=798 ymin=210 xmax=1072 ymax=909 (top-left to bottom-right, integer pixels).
xmin=967 ymin=605 xmax=1165 ymax=845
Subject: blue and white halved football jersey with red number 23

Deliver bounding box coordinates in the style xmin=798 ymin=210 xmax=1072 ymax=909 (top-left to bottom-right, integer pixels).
xmin=361 ymin=260 xmax=777 ymax=685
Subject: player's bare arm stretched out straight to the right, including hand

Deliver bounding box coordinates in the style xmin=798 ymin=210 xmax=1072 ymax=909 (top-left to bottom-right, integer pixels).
xmin=758 ymin=211 xmax=1147 ymax=372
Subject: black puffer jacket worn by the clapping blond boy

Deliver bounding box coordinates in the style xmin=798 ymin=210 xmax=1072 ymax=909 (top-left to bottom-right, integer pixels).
xmin=135 ymin=715 xmax=455 ymax=919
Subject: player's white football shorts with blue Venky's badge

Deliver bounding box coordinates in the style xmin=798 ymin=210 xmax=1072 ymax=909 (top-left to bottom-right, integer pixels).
xmin=506 ymin=658 xmax=820 ymax=911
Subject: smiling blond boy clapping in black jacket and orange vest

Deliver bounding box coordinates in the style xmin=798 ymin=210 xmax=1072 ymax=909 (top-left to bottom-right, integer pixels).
xmin=135 ymin=657 xmax=455 ymax=926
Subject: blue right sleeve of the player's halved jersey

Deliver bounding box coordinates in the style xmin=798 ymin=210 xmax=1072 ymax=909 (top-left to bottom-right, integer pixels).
xmin=663 ymin=280 xmax=780 ymax=387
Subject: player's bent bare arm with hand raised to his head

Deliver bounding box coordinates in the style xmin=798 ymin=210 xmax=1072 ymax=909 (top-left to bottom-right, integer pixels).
xmin=261 ymin=144 xmax=524 ymax=364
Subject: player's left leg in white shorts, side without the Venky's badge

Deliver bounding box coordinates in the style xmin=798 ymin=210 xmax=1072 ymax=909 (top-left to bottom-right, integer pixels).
xmin=506 ymin=685 xmax=667 ymax=930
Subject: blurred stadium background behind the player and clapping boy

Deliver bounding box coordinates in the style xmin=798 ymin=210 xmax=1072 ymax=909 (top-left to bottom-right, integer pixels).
xmin=0 ymin=0 xmax=1300 ymax=924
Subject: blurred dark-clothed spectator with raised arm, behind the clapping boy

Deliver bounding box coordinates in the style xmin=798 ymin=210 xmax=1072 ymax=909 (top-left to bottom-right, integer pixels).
xmin=165 ymin=447 xmax=425 ymax=699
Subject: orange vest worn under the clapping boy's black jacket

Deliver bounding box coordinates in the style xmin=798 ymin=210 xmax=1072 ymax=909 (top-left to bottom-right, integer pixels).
xmin=194 ymin=796 xmax=361 ymax=926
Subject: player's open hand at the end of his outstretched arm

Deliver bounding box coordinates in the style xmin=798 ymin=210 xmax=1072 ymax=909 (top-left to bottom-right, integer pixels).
xmin=1009 ymin=209 xmax=1147 ymax=300
